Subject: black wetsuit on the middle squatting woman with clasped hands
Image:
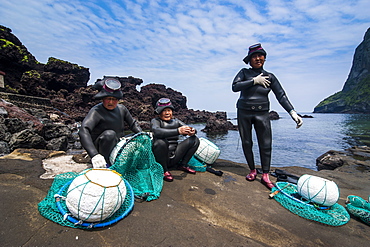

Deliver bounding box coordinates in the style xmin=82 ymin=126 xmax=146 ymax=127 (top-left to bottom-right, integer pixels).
xmin=151 ymin=118 xmax=199 ymax=172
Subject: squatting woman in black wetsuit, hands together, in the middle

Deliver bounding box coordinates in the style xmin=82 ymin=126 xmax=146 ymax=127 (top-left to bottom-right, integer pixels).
xmin=150 ymin=98 xmax=199 ymax=182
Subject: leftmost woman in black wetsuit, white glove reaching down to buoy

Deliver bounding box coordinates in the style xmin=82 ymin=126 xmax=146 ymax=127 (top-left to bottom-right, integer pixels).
xmin=78 ymin=76 xmax=142 ymax=168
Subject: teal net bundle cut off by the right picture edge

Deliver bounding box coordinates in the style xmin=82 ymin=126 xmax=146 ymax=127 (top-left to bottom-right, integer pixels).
xmin=346 ymin=195 xmax=370 ymax=225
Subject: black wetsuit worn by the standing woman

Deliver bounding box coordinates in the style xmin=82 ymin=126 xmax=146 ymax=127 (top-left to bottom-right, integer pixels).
xmin=232 ymin=68 xmax=294 ymax=173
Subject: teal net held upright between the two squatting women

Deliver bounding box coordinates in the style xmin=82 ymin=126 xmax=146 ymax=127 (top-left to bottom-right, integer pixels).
xmin=110 ymin=132 xmax=163 ymax=201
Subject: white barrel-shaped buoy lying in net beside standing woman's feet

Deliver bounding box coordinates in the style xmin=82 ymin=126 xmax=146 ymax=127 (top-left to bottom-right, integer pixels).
xmin=297 ymin=174 xmax=339 ymax=207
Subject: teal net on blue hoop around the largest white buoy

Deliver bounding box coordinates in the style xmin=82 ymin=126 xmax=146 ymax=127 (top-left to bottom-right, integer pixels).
xmin=38 ymin=172 xmax=134 ymax=229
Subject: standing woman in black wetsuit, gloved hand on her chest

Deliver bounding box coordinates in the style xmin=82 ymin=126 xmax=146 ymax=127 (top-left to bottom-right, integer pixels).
xmin=232 ymin=44 xmax=303 ymax=189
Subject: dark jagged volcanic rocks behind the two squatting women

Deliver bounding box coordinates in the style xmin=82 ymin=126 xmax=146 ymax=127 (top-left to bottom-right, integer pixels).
xmin=0 ymin=25 xmax=236 ymax=154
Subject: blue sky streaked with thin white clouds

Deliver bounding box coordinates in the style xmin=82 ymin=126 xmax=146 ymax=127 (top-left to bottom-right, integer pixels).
xmin=0 ymin=0 xmax=370 ymax=113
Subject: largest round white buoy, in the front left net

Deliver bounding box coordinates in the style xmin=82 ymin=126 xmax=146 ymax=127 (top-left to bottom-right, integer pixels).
xmin=66 ymin=168 xmax=126 ymax=222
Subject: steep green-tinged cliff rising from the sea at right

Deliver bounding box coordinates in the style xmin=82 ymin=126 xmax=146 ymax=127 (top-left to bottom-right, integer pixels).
xmin=314 ymin=28 xmax=370 ymax=113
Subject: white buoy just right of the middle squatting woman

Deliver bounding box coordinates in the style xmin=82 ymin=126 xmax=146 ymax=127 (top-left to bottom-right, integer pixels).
xmin=194 ymin=137 xmax=221 ymax=165
